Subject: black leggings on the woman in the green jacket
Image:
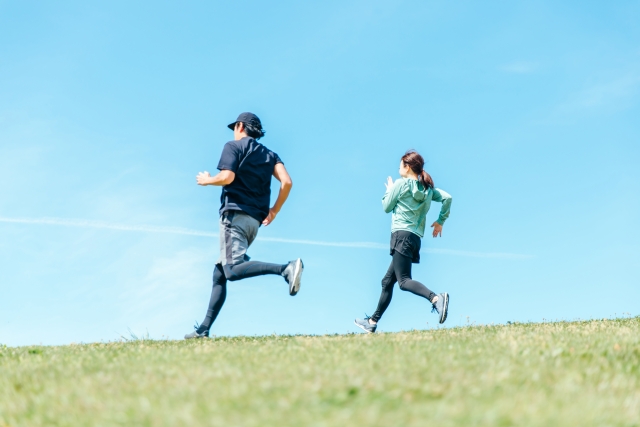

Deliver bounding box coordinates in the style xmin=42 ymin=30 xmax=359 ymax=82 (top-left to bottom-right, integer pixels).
xmin=371 ymin=252 xmax=436 ymax=322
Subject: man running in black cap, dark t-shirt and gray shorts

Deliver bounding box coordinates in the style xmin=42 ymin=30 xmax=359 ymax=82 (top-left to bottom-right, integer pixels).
xmin=184 ymin=113 xmax=304 ymax=339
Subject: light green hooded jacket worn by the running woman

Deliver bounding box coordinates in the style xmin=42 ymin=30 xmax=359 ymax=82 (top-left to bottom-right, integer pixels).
xmin=382 ymin=178 xmax=451 ymax=237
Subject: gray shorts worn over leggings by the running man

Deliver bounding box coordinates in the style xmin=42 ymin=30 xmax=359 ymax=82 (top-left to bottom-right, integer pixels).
xmin=218 ymin=211 xmax=260 ymax=265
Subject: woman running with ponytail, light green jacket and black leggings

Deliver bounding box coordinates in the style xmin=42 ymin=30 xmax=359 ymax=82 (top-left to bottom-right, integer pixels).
xmin=355 ymin=150 xmax=451 ymax=333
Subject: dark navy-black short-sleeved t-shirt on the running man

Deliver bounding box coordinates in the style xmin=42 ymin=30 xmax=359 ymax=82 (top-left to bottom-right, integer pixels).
xmin=218 ymin=137 xmax=282 ymax=222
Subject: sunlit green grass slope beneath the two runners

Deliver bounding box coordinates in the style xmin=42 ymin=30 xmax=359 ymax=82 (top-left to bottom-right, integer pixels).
xmin=0 ymin=318 xmax=640 ymax=427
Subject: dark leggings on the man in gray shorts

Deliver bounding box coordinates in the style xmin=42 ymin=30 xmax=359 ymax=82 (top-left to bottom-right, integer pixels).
xmin=197 ymin=261 xmax=287 ymax=333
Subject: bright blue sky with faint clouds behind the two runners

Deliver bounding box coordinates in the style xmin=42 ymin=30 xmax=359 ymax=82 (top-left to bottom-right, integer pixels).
xmin=0 ymin=0 xmax=640 ymax=345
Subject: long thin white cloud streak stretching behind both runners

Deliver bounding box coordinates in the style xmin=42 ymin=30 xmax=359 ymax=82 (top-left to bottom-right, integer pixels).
xmin=0 ymin=217 xmax=533 ymax=259
